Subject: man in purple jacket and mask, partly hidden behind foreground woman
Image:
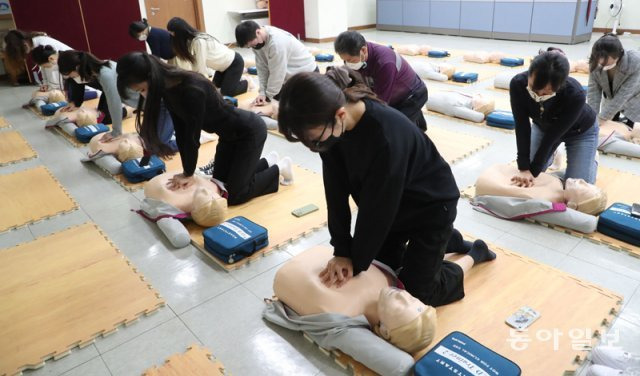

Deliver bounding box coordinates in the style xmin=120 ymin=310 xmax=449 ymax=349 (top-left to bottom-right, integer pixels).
xmin=334 ymin=31 xmax=428 ymax=131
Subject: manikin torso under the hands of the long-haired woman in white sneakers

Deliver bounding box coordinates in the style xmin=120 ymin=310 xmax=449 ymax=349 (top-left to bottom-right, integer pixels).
xmin=144 ymin=172 xmax=220 ymax=213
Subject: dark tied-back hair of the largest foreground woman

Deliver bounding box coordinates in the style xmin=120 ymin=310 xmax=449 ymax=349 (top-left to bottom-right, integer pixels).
xmin=278 ymin=72 xmax=382 ymax=147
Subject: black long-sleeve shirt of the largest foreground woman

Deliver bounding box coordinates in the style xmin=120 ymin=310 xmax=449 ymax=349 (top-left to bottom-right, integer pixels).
xmin=320 ymin=100 xmax=460 ymax=275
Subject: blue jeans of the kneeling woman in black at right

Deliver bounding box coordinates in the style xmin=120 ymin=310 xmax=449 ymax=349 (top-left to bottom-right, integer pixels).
xmin=530 ymin=119 xmax=599 ymax=184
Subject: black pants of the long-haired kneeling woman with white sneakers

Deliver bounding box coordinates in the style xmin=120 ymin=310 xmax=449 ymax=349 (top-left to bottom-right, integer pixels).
xmin=213 ymin=116 xmax=280 ymax=205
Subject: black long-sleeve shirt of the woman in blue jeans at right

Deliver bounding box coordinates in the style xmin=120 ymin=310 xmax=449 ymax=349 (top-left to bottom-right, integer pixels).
xmin=509 ymin=72 xmax=596 ymax=176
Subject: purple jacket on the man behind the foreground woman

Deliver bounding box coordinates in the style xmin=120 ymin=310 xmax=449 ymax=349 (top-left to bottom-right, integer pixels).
xmin=359 ymin=42 xmax=422 ymax=106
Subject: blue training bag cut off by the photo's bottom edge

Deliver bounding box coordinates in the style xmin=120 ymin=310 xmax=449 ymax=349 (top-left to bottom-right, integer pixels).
xmin=413 ymin=332 xmax=522 ymax=376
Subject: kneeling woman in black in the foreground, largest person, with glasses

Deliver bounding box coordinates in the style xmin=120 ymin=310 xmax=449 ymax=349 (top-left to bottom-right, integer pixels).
xmin=278 ymin=73 xmax=495 ymax=306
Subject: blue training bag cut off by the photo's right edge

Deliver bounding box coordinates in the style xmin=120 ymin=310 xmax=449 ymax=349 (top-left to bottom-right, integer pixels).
xmin=598 ymin=202 xmax=640 ymax=246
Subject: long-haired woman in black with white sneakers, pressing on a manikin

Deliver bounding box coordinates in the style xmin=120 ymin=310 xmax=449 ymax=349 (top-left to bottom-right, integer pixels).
xmin=117 ymin=52 xmax=293 ymax=205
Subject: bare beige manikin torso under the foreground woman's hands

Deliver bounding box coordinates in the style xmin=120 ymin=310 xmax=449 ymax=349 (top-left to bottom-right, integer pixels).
xmin=273 ymin=247 xmax=393 ymax=326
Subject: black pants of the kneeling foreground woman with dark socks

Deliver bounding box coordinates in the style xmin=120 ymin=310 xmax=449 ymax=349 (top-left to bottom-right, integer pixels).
xmin=376 ymin=200 xmax=464 ymax=307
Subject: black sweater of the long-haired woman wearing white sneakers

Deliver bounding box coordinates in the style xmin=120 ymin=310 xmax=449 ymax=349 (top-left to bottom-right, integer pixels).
xmin=163 ymin=73 xmax=265 ymax=176
